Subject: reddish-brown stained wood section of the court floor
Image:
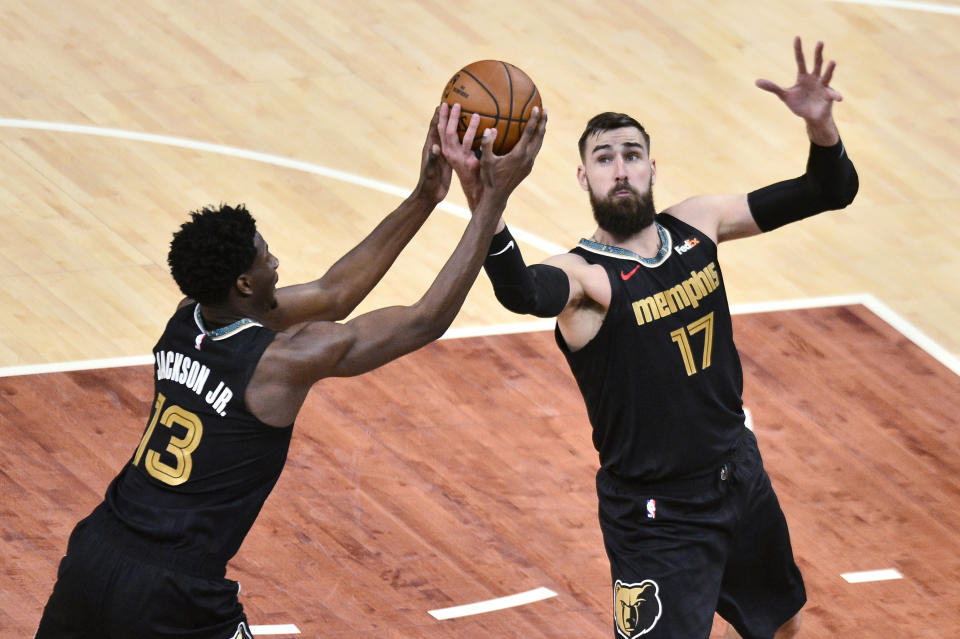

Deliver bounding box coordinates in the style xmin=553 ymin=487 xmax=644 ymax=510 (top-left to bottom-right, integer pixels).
xmin=0 ymin=305 xmax=960 ymax=639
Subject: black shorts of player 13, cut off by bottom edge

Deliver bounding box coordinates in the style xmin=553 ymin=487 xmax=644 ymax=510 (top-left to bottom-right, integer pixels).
xmin=36 ymin=509 xmax=252 ymax=639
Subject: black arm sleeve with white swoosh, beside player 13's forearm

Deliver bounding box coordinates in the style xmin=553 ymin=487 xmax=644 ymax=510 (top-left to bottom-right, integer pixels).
xmin=483 ymin=228 xmax=570 ymax=317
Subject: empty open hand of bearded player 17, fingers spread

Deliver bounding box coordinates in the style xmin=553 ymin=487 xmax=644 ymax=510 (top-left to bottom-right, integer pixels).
xmin=756 ymin=36 xmax=843 ymax=129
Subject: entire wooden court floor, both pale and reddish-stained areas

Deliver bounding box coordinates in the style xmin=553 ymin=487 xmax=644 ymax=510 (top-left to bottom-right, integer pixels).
xmin=0 ymin=0 xmax=960 ymax=639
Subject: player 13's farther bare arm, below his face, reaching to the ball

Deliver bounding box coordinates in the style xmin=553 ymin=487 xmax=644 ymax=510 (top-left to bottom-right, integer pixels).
xmin=266 ymin=109 xmax=451 ymax=330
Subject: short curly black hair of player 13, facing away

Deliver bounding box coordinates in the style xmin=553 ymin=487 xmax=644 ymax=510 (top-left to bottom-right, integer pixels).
xmin=167 ymin=204 xmax=257 ymax=304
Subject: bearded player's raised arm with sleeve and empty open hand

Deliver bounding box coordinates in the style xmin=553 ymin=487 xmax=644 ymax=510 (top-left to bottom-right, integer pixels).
xmin=666 ymin=37 xmax=859 ymax=241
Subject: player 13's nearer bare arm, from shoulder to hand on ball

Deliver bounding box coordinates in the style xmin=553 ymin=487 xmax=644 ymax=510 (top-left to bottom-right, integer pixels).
xmin=247 ymin=108 xmax=546 ymax=425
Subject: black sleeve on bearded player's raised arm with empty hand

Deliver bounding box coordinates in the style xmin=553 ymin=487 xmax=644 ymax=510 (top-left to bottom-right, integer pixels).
xmin=747 ymin=141 xmax=860 ymax=231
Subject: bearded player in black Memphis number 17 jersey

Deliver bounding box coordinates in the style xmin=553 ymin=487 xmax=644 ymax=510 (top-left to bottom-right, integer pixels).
xmin=441 ymin=38 xmax=858 ymax=639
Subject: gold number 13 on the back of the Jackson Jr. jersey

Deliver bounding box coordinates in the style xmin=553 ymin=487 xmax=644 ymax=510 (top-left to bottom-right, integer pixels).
xmin=133 ymin=393 xmax=203 ymax=486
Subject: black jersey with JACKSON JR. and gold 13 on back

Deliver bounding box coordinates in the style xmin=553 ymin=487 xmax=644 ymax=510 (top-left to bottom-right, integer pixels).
xmin=106 ymin=304 xmax=293 ymax=565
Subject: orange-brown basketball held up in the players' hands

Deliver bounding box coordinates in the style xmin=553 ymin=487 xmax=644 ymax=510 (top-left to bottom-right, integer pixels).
xmin=441 ymin=60 xmax=543 ymax=155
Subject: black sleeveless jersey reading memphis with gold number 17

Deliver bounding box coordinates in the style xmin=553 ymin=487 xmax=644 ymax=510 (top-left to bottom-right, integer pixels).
xmin=556 ymin=214 xmax=744 ymax=481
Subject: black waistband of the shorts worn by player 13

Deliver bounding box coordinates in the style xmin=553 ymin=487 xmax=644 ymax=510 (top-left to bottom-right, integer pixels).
xmin=87 ymin=504 xmax=227 ymax=579
